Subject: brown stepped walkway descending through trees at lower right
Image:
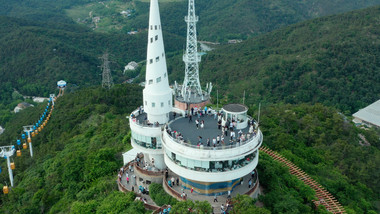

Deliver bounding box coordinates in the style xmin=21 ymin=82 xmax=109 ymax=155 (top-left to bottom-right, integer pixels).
xmin=260 ymin=146 xmax=346 ymax=214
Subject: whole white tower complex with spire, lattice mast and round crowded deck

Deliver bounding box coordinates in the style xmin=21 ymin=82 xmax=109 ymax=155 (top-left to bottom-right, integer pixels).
xmin=120 ymin=0 xmax=263 ymax=200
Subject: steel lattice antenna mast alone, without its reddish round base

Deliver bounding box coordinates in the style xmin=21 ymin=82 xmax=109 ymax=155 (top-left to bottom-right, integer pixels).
xmin=181 ymin=0 xmax=203 ymax=100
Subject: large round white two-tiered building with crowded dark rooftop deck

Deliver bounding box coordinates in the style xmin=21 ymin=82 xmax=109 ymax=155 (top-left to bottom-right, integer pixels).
xmin=162 ymin=103 xmax=263 ymax=183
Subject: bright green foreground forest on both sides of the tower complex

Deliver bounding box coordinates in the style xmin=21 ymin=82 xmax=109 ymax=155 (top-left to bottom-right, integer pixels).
xmin=0 ymin=84 xmax=380 ymax=214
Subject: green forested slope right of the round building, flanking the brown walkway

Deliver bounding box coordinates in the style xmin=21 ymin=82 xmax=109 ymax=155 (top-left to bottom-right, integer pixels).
xmin=258 ymin=104 xmax=380 ymax=213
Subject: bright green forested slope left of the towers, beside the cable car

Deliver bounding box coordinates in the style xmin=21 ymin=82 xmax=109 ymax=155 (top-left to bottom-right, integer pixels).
xmin=0 ymin=85 xmax=145 ymax=214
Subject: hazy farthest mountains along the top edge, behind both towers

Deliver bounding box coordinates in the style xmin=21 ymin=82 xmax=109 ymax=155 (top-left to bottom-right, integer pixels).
xmin=0 ymin=0 xmax=380 ymax=41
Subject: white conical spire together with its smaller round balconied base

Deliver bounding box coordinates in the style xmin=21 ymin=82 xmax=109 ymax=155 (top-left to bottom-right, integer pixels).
xmin=129 ymin=0 xmax=173 ymax=170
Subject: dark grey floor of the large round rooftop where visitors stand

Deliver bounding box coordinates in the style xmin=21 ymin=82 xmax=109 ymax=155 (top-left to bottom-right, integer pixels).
xmin=169 ymin=115 xmax=249 ymax=146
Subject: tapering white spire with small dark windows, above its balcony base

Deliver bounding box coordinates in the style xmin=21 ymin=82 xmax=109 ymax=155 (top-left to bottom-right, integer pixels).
xmin=143 ymin=0 xmax=172 ymax=124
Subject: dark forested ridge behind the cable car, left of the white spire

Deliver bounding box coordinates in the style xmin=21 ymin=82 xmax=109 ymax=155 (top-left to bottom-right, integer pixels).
xmin=0 ymin=17 xmax=182 ymax=95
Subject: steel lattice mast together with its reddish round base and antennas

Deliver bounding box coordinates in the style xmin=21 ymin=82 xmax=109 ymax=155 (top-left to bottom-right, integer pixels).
xmin=174 ymin=0 xmax=212 ymax=110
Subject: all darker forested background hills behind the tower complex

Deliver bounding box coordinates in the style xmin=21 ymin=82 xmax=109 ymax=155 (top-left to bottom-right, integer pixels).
xmin=0 ymin=0 xmax=380 ymax=124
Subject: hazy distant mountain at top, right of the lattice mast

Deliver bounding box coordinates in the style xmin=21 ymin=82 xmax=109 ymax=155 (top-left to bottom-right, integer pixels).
xmin=196 ymin=0 xmax=380 ymax=41
